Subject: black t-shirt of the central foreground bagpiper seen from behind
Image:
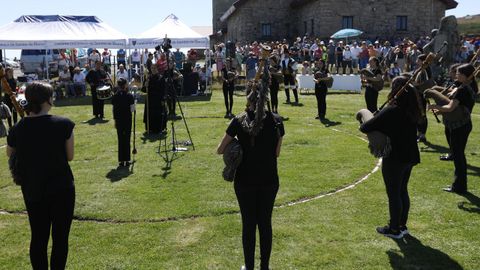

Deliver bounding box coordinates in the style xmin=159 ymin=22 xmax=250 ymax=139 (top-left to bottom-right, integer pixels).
xmin=227 ymin=112 xmax=285 ymax=188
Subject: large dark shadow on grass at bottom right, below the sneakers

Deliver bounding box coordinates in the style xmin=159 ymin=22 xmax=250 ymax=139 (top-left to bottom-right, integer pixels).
xmin=387 ymin=235 xmax=463 ymax=270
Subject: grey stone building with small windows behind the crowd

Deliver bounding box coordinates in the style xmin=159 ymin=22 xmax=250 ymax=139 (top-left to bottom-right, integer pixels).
xmin=212 ymin=0 xmax=458 ymax=42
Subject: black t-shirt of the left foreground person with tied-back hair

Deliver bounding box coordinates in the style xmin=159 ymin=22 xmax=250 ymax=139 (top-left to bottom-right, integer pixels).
xmin=7 ymin=115 xmax=75 ymax=200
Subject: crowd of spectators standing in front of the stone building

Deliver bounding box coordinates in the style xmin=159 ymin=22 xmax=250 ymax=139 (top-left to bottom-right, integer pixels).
xmin=207 ymin=36 xmax=480 ymax=79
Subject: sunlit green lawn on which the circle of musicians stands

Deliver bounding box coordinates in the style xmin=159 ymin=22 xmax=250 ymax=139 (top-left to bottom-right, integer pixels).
xmin=0 ymin=83 xmax=480 ymax=269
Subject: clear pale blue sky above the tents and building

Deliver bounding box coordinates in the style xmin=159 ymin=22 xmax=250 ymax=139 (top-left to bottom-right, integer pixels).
xmin=0 ymin=0 xmax=480 ymax=58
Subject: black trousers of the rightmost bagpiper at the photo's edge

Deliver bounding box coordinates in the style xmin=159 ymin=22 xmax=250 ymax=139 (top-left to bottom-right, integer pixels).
xmin=450 ymin=122 xmax=472 ymax=192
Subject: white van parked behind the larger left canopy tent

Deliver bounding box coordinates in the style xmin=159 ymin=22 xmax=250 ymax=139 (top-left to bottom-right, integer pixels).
xmin=20 ymin=49 xmax=60 ymax=75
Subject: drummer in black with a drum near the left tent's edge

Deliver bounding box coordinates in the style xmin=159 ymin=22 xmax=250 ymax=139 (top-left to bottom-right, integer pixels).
xmin=85 ymin=61 xmax=109 ymax=118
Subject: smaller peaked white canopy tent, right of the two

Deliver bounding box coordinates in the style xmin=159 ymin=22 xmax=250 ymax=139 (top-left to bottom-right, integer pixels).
xmin=129 ymin=14 xmax=209 ymax=49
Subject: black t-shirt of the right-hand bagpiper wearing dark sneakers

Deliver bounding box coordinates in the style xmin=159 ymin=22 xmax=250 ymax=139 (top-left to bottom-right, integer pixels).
xmin=360 ymin=105 xmax=420 ymax=164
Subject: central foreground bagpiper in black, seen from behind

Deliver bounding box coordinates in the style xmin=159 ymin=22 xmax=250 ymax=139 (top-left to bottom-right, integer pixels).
xmin=217 ymin=87 xmax=285 ymax=270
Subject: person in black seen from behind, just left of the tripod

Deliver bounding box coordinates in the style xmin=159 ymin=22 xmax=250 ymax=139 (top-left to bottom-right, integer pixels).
xmin=112 ymin=78 xmax=135 ymax=167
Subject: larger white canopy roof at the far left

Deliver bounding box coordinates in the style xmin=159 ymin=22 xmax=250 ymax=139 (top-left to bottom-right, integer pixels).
xmin=0 ymin=15 xmax=128 ymax=49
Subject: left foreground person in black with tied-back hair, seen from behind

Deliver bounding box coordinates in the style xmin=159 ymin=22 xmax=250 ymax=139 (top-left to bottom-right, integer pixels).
xmin=7 ymin=82 xmax=75 ymax=269
